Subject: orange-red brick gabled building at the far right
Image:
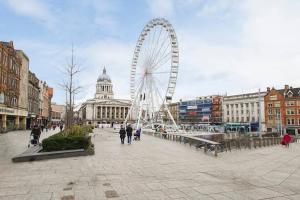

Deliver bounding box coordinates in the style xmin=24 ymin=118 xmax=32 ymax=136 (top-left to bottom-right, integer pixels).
xmin=264 ymin=85 xmax=300 ymax=135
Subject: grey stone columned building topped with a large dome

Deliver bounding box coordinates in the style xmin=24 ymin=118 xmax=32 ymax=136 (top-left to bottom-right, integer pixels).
xmin=79 ymin=67 xmax=131 ymax=126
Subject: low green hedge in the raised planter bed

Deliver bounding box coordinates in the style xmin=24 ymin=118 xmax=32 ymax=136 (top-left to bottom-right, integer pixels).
xmin=42 ymin=133 xmax=91 ymax=151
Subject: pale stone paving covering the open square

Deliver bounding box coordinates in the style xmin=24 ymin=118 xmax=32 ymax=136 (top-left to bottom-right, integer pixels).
xmin=0 ymin=129 xmax=300 ymax=200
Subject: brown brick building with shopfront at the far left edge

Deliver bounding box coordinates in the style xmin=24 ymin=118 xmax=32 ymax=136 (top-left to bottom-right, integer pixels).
xmin=0 ymin=42 xmax=27 ymax=131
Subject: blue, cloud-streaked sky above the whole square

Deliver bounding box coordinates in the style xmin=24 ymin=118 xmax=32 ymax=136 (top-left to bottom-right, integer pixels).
xmin=0 ymin=0 xmax=300 ymax=103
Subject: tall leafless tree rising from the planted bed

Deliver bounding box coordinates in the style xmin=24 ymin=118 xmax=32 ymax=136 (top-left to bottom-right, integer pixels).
xmin=59 ymin=45 xmax=81 ymax=128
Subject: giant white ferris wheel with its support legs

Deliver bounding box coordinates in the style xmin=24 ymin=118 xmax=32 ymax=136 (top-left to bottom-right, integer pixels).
xmin=125 ymin=18 xmax=179 ymax=130
